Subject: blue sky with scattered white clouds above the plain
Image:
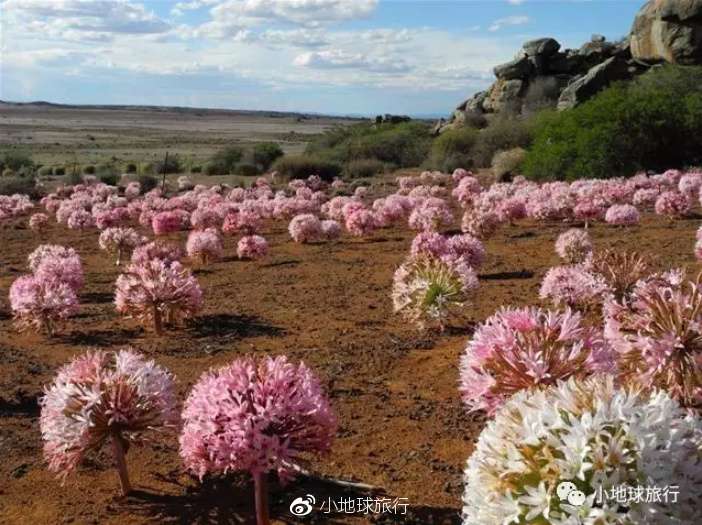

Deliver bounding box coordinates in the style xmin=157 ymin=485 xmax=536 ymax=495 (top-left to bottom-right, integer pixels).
xmin=0 ymin=0 xmax=643 ymax=115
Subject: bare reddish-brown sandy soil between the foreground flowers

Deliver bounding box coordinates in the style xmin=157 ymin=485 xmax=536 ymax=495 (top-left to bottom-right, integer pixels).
xmin=0 ymin=200 xmax=699 ymax=525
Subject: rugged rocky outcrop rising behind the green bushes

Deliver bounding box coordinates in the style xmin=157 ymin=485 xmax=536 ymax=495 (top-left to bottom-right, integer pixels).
xmin=435 ymin=0 xmax=702 ymax=133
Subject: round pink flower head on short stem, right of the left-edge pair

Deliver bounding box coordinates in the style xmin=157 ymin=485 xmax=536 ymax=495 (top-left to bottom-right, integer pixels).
xmin=115 ymin=259 xmax=202 ymax=335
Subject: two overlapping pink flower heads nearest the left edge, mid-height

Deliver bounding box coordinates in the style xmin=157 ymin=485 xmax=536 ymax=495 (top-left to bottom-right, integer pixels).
xmin=10 ymin=244 xmax=83 ymax=336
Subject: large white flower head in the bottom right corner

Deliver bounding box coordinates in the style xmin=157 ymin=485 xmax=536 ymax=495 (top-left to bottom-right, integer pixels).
xmin=463 ymin=377 xmax=702 ymax=525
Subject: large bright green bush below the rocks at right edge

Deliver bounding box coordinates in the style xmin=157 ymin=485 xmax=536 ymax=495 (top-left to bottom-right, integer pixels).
xmin=524 ymin=66 xmax=702 ymax=180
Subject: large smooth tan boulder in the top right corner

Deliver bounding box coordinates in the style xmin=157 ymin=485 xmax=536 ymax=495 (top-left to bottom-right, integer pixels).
xmin=630 ymin=0 xmax=702 ymax=65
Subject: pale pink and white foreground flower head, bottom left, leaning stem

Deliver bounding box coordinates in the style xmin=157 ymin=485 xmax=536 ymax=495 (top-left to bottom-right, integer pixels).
xmin=39 ymin=350 xmax=178 ymax=479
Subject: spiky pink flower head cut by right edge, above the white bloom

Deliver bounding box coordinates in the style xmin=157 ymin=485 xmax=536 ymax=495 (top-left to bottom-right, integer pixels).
xmin=605 ymin=278 xmax=702 ymax=410
